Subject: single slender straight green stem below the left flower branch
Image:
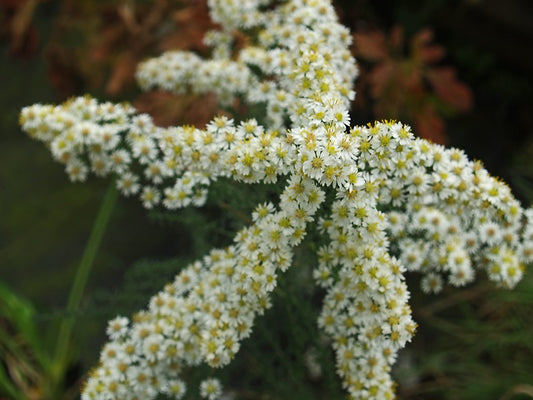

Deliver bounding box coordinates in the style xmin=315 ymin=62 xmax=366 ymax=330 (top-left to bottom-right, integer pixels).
xmin=50 ymin=183 xmax=118 ymax=395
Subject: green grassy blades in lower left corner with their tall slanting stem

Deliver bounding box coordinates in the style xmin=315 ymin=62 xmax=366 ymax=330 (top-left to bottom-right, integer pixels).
xmin=0 ymin=187 xmax=117 ymax=399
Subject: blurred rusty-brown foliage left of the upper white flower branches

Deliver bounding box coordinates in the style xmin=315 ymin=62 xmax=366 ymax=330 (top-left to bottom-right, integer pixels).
xmin=0 ymin=0 xmax=219 ymax=125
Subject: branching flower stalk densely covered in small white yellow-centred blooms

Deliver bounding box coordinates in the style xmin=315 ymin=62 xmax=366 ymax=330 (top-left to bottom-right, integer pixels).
xmin=20 ymin=0 xmax=533 ymax=399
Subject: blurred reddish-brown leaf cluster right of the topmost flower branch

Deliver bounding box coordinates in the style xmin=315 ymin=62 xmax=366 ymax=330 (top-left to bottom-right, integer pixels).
xmin=354 ymin=26 xmax=473 ymax=144
